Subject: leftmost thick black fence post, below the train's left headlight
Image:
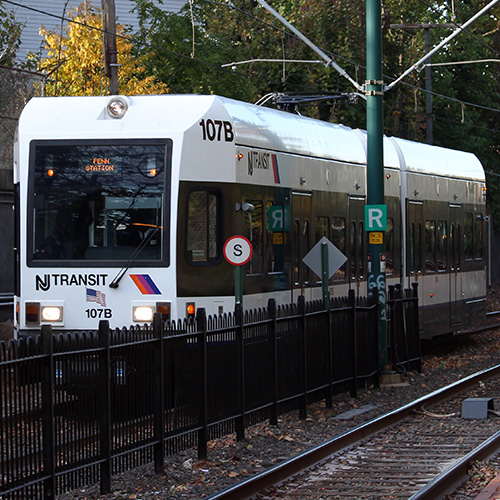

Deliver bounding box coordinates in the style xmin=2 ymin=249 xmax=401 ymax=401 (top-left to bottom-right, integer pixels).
xmin=41 ymin=325 xmax=56 ymax=500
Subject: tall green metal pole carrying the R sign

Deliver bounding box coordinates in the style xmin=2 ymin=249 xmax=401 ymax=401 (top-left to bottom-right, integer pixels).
xmin=366 ymin=0 xmax=388 ymax=370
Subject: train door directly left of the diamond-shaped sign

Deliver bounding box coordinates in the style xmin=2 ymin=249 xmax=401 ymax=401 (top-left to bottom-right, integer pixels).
xmin=291 ymin=191 xmax=312 ymax=302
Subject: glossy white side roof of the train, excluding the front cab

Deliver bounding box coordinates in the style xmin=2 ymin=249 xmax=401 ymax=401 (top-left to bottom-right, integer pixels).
xmin=220 ymin=98 xmax=485 ymax=181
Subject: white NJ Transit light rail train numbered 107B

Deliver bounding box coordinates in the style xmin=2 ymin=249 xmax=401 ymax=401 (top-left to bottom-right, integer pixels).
xmin=14 ymin=95 xmax=487 ymax=337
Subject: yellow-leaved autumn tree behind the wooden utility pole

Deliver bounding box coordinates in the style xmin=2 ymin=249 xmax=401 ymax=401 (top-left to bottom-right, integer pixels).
xmin=39 ymin=2 xmax=168 ymax=95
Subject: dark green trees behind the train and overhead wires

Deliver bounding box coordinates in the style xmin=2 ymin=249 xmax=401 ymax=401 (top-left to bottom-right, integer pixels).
xmin=113 ymin=0 xmax=500 ymax=220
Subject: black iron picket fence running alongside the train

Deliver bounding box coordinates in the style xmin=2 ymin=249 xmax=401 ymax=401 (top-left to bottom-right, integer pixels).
xmin=0 ymin=293 xmax=417 ymax=500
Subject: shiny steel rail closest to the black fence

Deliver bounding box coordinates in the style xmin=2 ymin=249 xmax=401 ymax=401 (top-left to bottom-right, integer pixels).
xmin=208 ymin=365 xmax=500 ymax=500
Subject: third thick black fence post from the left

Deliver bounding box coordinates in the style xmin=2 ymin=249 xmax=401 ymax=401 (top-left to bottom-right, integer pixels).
xmin=153 ymin=313 xmax=165 ymax=474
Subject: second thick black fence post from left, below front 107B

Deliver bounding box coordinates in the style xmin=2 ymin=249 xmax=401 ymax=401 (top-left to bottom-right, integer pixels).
xmin=98 ymin=320 xmax=112 ymax=494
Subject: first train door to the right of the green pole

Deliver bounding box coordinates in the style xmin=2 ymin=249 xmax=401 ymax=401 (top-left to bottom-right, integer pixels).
xmin=405 ymin=200 xmax=425 ymax=331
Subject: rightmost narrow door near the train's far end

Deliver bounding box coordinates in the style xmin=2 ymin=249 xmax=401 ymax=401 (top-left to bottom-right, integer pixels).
xmin=449 ymin=205 xmax=463 ymax=326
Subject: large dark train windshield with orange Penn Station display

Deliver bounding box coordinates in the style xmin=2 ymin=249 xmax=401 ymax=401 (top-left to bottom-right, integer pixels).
xmin=28 ymin=141 xmax=170 ymax=266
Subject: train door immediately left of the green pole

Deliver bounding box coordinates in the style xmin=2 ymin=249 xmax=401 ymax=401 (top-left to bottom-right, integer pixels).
xmin=349 ymin=196 xmax=366 ymax=293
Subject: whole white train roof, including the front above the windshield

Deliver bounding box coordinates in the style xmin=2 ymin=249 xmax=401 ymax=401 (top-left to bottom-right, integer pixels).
xmin=20 ymin=94 xmax=485 ymax=181
